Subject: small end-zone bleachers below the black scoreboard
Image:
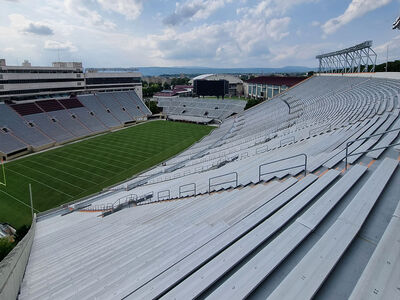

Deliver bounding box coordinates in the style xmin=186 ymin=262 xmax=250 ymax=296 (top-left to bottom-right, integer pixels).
xmin=158 ymin=97 xmax=246 ymax=123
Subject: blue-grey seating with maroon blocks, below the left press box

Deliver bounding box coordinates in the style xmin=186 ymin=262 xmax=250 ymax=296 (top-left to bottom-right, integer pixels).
xmin=0 ymin=91 xmax=151 ymax=155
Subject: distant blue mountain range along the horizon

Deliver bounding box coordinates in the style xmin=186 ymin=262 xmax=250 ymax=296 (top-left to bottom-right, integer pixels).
xmin=137 ymin=66 xmax=316 ymax=76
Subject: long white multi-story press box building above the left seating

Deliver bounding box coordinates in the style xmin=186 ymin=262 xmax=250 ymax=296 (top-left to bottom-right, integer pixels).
xmin=0 ymin=59 xmax=142 ymax=101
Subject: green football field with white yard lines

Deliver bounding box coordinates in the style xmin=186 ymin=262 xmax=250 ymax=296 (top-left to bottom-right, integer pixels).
xmin=0 ymin=121 xmax=213 ymax=227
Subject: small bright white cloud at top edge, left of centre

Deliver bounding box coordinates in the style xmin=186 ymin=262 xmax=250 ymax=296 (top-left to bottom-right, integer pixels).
xmin=97 ymin=0 xmax=143 ymax=20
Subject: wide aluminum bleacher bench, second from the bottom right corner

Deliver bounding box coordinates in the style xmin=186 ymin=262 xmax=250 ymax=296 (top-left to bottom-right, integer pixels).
xmin=268 ymin=158 xmax=398 ymax=299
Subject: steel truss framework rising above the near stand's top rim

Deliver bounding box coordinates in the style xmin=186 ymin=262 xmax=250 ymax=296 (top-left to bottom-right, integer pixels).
xmin=316 ymin=41 xmax=377 ymax=73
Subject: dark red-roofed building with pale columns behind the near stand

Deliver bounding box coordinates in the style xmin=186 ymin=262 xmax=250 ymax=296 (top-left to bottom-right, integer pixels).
xmin=244 ymin=76 xmax=305 ymax=99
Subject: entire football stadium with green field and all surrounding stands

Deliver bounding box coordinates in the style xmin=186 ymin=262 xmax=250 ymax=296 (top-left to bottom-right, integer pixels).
xmin=0 ymin=4 xmax=400 ymax=300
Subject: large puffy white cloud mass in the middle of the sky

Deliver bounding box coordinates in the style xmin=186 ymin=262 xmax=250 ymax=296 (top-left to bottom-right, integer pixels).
xmin=148 ymin=17 xmax=290 ymax=65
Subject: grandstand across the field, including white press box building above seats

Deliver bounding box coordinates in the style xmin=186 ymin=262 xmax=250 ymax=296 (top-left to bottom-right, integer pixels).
xmin=0 ymin=59 xmax=151 ymax=160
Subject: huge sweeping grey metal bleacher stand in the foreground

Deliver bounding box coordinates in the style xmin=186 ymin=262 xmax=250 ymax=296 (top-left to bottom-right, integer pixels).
xmin=19 ymin=75 xmax=400 ymax=299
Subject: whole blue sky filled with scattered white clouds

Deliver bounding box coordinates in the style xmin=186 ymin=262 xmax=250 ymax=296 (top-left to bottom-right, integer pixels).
xmin=0 ymin=0 xmax=400 ymax=67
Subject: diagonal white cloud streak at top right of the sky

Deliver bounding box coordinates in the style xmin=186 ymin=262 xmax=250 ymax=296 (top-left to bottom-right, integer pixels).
xmin=322 ymin=0 xmax=392 ymax=34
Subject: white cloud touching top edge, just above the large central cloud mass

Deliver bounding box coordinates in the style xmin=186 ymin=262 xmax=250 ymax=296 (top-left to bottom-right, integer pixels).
xmin=163 ymin=0 xmax=232 ymax=26
